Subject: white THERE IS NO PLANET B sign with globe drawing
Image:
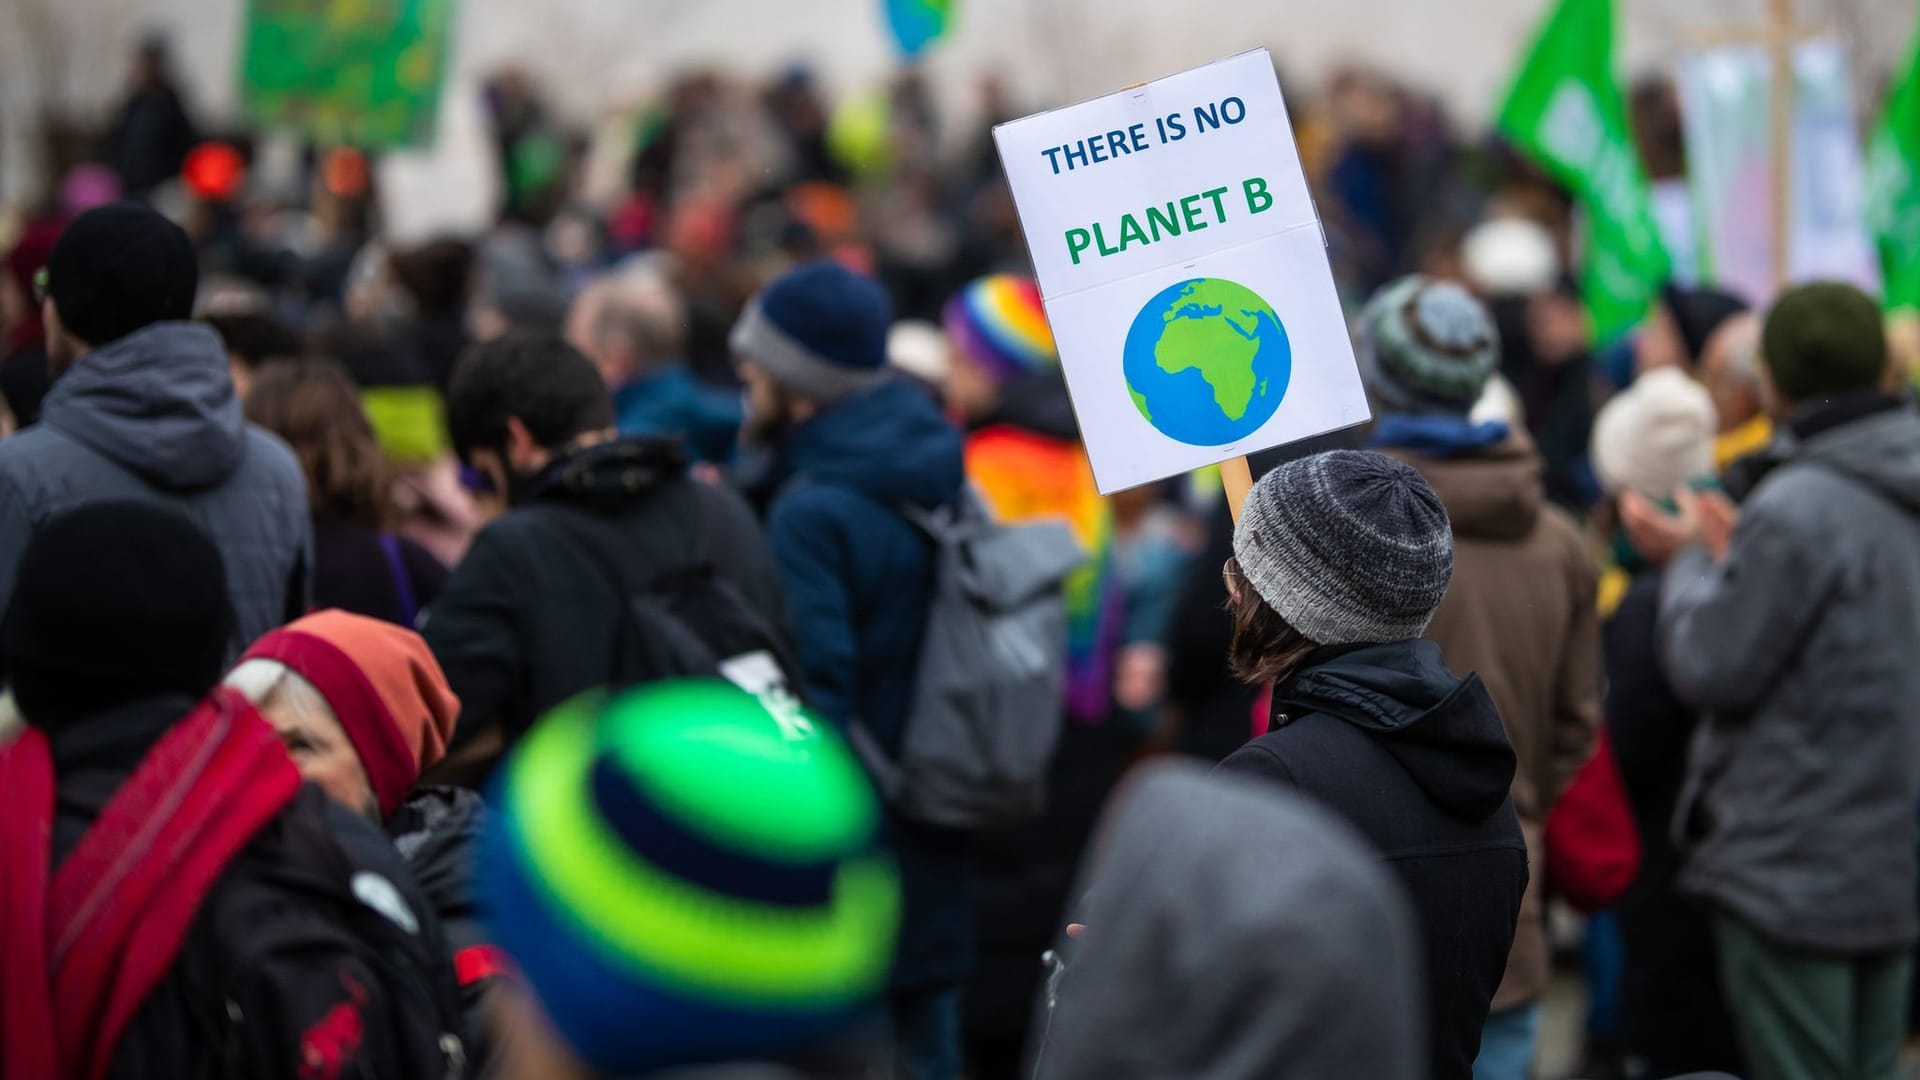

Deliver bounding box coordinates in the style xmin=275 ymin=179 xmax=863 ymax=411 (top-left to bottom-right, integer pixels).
xmin=993 ymin=48 xmax=1369 ymax=494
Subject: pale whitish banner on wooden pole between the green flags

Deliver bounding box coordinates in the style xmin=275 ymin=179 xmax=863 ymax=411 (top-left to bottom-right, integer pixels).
xmin=1678 ymin=38 xmax=1880 ymax=304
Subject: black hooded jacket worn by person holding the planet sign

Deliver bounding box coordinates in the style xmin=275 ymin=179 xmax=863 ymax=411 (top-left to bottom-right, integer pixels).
xmin=1221 ymin=642 xmax=1526 ymax=1080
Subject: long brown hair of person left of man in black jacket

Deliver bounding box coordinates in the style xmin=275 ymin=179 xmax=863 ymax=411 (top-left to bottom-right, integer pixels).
xmin=246 ymin=359 xmax=394 ymax=528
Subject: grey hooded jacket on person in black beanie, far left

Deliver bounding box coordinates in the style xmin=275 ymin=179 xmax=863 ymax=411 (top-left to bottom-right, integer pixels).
xmin=0 ymin=323 xmax=313 ymax=661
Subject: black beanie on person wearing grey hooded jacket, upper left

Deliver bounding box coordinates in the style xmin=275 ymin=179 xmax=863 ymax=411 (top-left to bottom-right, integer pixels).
xmin=46 ymin=202 xmax=200 ymax=348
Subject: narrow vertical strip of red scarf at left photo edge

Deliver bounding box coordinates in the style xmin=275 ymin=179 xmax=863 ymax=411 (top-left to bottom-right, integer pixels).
xmin=0 ymin=728 xmax=60 ymax=1076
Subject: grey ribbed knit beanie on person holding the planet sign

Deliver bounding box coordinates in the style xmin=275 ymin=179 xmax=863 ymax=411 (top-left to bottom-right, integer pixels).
xmin=1233 ymin=450 xmax=1453 ymax=646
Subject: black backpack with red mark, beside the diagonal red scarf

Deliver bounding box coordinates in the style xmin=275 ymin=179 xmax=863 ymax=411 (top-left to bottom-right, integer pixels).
xmin=180 ymin=786 xmax=476 ymax=1080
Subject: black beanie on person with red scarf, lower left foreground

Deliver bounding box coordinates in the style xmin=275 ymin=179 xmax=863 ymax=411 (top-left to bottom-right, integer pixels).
xmin=0 ymin=500 xmax=234 ymax=728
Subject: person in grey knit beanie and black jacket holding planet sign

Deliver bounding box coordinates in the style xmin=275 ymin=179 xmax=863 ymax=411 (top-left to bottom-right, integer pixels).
xmin=1219 ymin=450 xmax=1528 ymax=1080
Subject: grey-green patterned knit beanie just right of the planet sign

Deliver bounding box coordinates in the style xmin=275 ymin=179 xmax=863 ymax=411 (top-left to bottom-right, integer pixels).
xmin=1357 ymin=275 xmax=1500 ymax=415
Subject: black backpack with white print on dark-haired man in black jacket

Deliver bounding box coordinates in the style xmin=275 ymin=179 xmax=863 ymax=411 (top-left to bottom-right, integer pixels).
xmin=540 ymin=486 xmax=799 ymax=694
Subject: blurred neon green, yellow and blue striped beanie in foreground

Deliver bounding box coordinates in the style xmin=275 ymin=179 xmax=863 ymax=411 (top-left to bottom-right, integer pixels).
xmin=478 ymin=680 xmax=900 ymax=1074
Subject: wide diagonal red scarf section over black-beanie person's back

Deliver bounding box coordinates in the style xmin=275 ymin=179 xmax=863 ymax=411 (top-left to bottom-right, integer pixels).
xmin=46 ymin=690 xmax=300 ymax=1080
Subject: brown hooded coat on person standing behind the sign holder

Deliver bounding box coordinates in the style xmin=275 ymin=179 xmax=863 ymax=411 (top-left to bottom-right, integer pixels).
xmin=1392 ymin=428 xmax=1599 ymax=1011
